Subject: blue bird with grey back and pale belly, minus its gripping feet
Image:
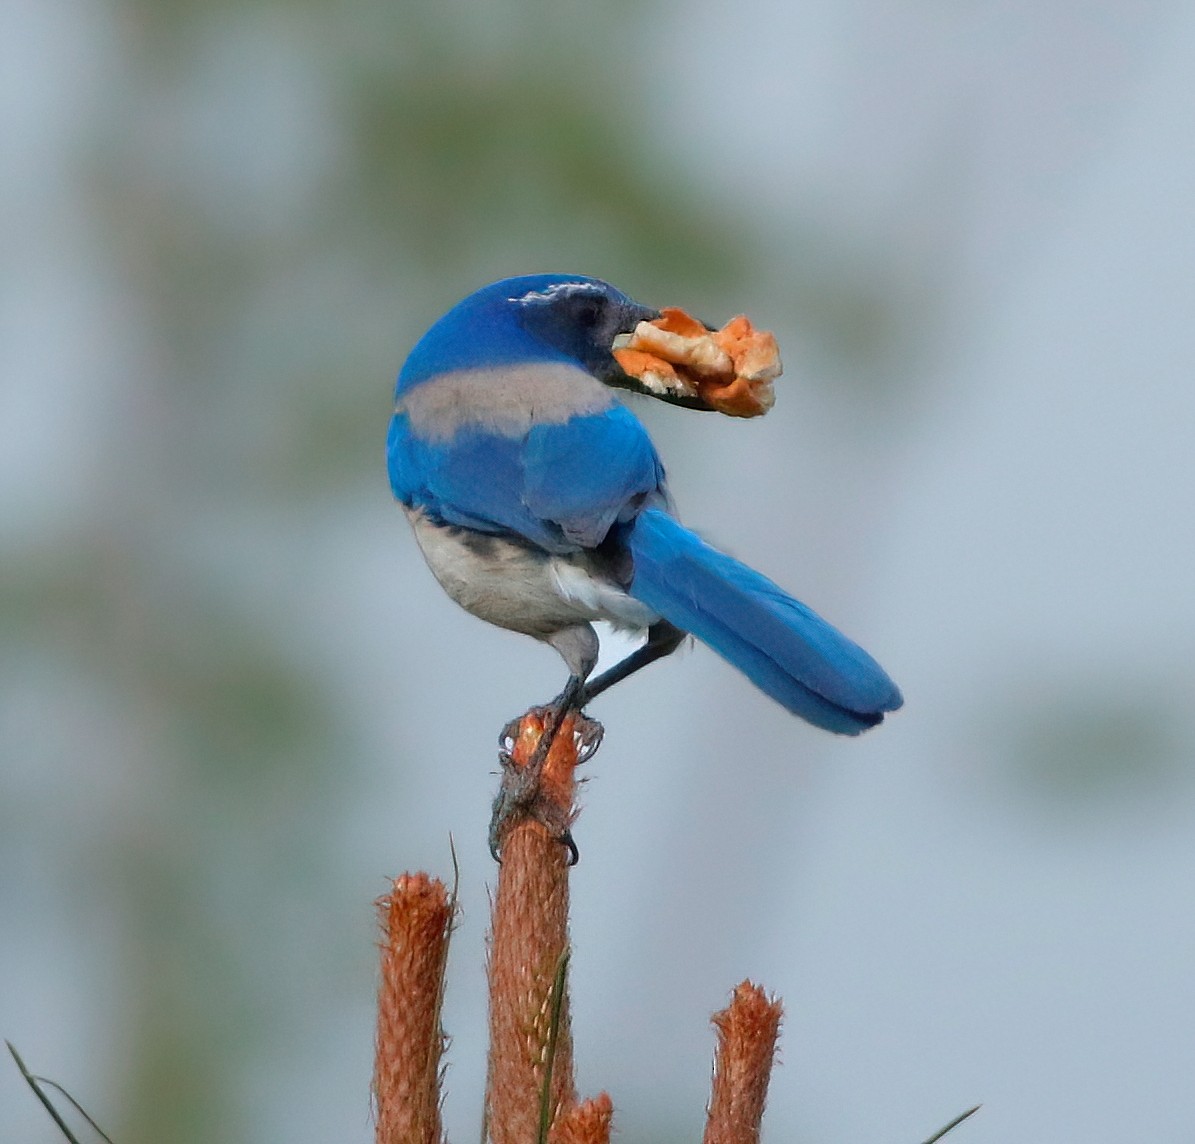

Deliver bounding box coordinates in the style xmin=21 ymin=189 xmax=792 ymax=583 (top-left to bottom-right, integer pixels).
xmin=387 ymin=274 xmax=902 ymax=735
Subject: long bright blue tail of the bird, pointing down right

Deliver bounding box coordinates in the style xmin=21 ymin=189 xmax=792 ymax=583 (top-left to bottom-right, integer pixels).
xmin=626 ymin=509 xmax=903 ymax=735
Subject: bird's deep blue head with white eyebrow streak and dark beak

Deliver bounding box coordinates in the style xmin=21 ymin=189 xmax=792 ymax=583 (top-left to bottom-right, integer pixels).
xmin=397 ymin=274 xmax=705 ymax=408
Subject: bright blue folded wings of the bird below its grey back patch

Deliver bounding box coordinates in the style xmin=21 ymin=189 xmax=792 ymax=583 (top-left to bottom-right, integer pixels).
xmin=387 ymin=405 xmax=664 ymax=552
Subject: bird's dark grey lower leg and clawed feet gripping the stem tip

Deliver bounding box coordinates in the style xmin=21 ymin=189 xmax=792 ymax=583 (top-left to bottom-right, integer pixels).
xmin=489 ymin=675 xmax=602 ymax=865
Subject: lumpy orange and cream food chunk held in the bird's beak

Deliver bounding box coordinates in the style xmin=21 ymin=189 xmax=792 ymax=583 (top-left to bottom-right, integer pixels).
xmin=613 ymin=306 xmax=782 ymax=417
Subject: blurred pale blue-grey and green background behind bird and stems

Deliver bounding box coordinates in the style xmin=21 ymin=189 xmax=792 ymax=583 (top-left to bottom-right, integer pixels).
xmin=0 ymin=0 xmax=1195 ymax=1144
